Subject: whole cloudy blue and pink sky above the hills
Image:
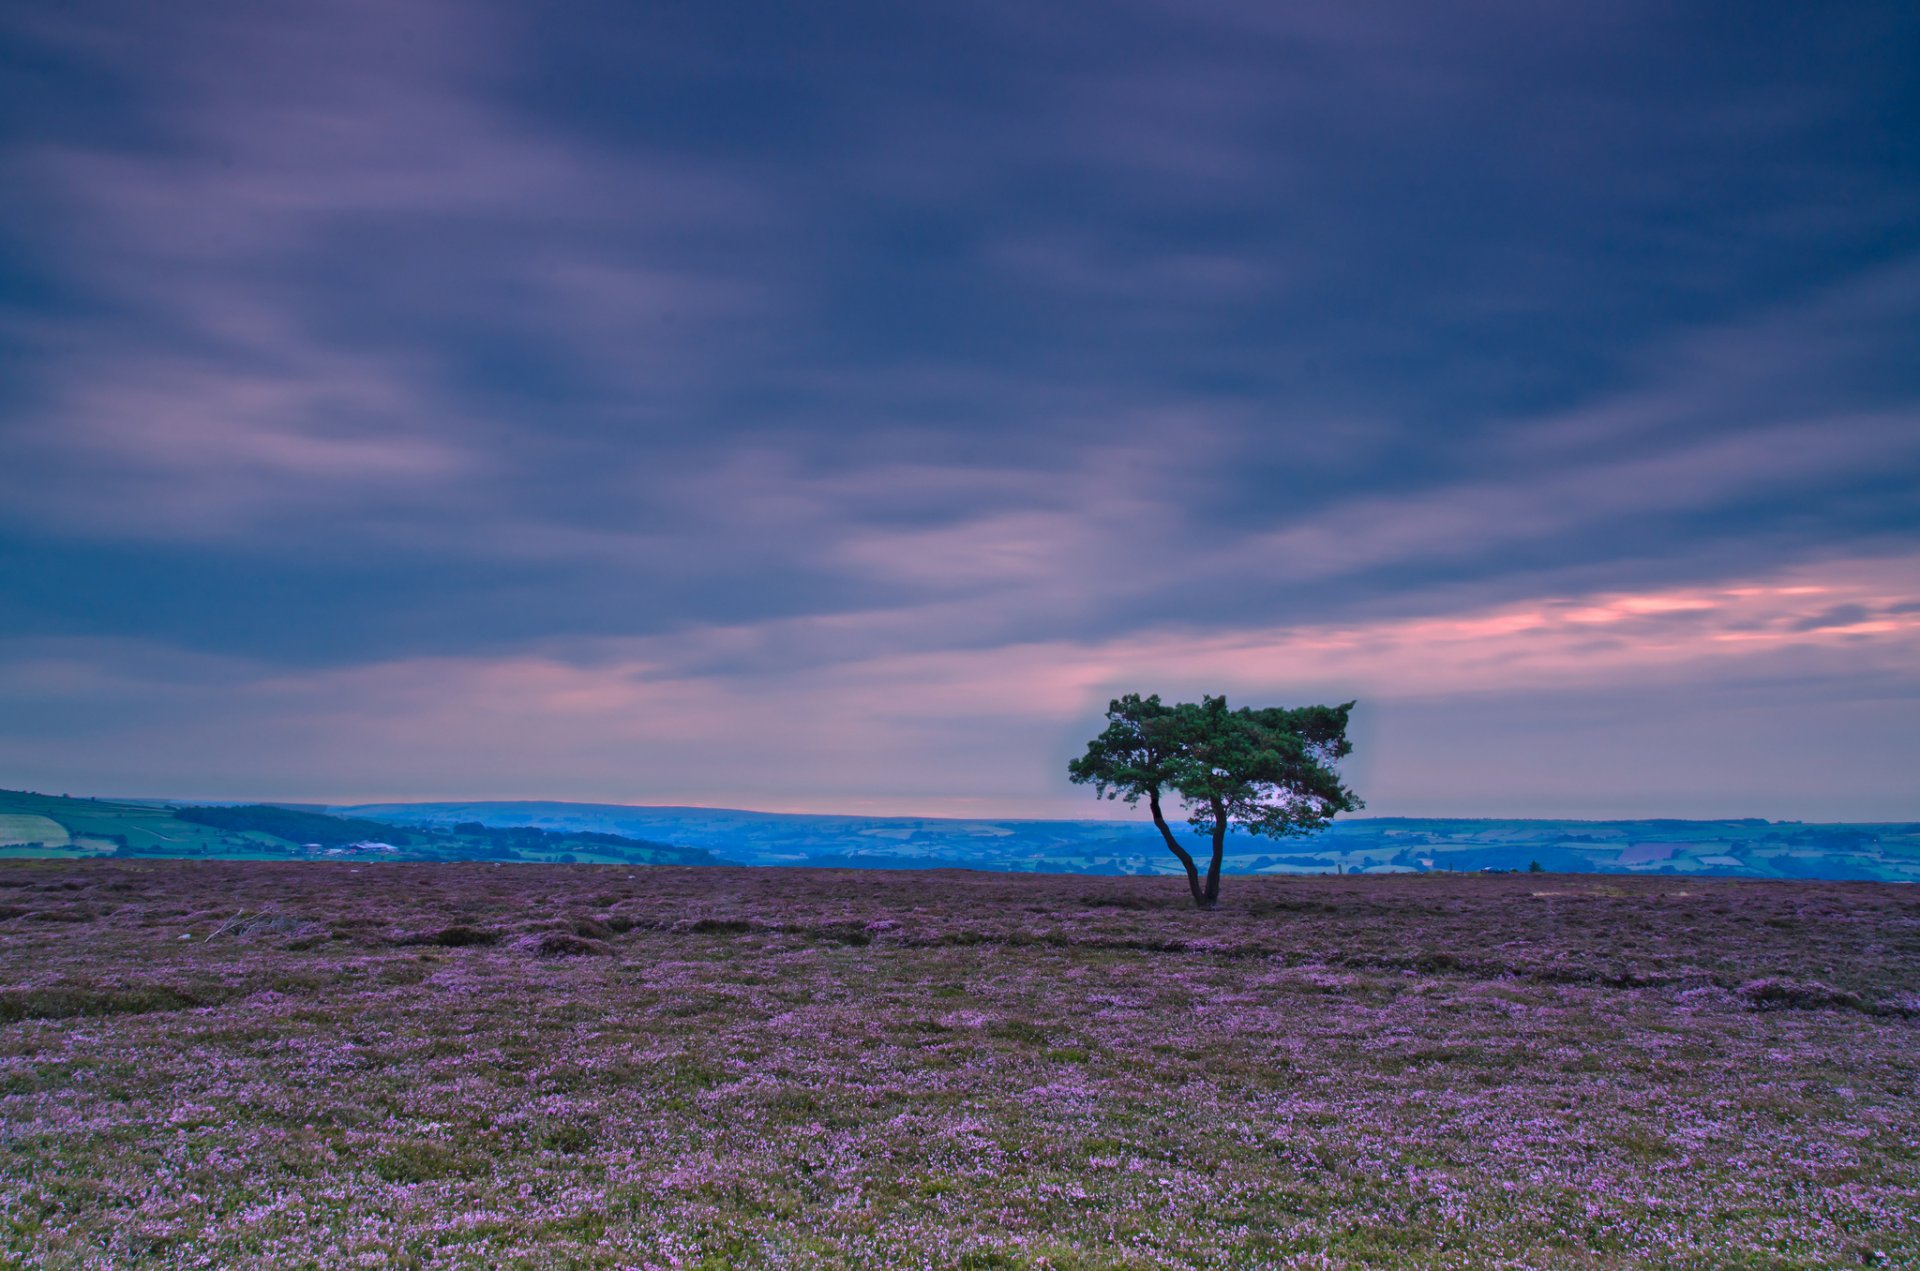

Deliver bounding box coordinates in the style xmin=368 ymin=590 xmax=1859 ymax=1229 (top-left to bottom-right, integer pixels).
xmin=0 ymin=0 xmax=1920 ymax=820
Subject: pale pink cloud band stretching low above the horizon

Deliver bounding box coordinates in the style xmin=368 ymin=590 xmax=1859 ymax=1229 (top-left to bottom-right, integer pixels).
xmin=0 ymin=557 xmax=1920 ymax=816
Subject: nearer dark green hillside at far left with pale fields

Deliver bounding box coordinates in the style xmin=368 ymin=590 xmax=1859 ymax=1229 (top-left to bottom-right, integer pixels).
xmin=0 ymin=791 xmax=722 ymax=864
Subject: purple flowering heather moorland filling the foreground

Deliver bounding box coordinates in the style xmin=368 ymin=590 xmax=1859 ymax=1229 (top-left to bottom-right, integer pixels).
xmin=0 ymin=860 xmax=1920 ymax=1267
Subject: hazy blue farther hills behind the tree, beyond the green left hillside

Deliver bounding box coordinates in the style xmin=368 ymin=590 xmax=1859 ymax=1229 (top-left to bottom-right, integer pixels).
xmin=330 ymin=803 xmax=1920 ymax=883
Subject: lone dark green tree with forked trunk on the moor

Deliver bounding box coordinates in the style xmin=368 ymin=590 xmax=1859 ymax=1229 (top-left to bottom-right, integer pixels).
xmin=1068 ymin=693 xmax=1365 ymax=908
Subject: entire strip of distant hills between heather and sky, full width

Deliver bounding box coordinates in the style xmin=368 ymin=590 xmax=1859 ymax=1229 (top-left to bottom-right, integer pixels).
xmin=0 ymin=791 xmax=1920 ymax=883
